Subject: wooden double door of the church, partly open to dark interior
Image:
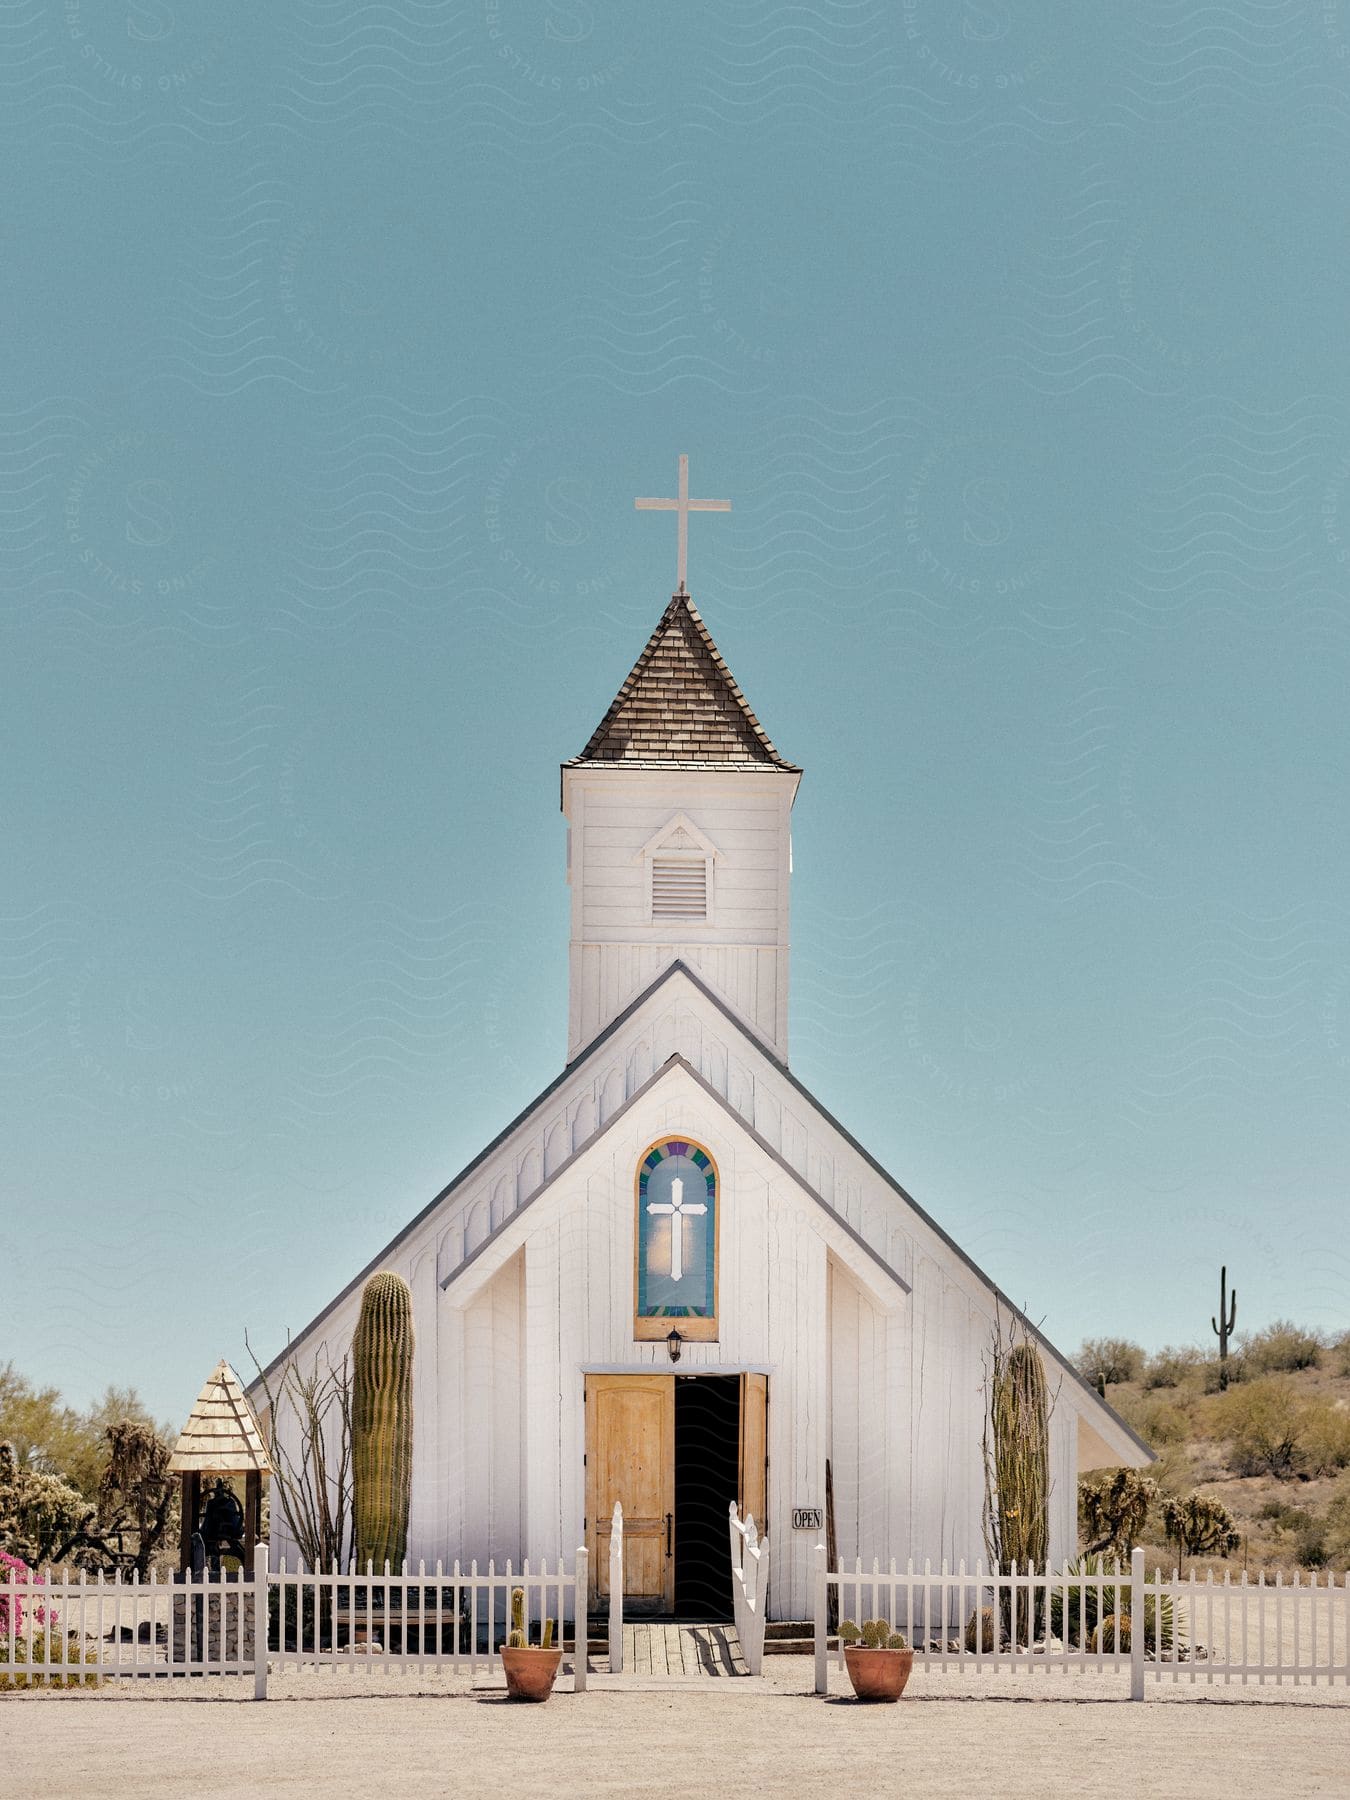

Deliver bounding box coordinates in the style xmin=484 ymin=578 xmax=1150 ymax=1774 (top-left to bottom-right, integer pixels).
xmin=585 ymin=1373 xmax=769 ymax=1618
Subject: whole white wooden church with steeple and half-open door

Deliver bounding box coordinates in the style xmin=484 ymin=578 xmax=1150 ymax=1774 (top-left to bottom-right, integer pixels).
xmin=254 ymin=481 xmax=1150 ymax=1618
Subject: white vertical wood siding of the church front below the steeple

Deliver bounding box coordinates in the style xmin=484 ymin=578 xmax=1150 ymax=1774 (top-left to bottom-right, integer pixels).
xmin=253 ymin=972 xmax=1143 ymax=1618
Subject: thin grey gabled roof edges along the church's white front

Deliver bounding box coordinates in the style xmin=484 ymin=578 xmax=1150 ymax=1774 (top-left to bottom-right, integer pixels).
xmin=254 ymin=959 xmax=1156 ymax=1462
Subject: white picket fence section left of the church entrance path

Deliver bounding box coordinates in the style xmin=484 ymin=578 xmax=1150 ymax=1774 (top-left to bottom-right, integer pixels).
xmin=0 ymin=1544 xmax=587 ymax=1699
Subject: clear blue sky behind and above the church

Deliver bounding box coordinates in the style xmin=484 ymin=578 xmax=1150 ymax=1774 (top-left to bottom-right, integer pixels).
xmin=0 ymin=0 xmax=1350 ymax=1417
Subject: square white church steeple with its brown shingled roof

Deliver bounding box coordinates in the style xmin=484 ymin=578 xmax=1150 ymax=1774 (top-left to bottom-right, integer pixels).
xmin=562 ymin=590 xmax=801 ymax=1060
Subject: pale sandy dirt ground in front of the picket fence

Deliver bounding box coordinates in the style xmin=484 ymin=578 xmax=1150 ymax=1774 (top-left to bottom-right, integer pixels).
xmin=0 ymin=1658 xmax=1350 ymax=1800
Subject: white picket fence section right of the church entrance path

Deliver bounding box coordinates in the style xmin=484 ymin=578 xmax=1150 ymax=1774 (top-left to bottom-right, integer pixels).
xmin=814 ymin=1544 xmax=1350 ymax=1699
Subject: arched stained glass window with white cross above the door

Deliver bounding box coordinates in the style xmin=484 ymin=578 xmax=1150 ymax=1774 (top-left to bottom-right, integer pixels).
xmin=634 ymin=1136 xmax=720 ymax=1339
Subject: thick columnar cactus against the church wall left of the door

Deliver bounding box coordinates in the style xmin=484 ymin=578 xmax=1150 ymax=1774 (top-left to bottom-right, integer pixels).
xmin=351 ymin=1273 xmax=412 ymax=1573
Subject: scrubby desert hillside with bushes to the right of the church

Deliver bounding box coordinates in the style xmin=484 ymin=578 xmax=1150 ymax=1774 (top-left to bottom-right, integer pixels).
xmin=1078 ymin=1321 xmax=1350 ymax=1573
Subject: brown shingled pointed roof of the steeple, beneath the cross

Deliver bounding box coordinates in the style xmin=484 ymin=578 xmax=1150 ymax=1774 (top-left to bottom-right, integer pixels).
xmin=563 ymin=594 xmax=801 ymax=774
